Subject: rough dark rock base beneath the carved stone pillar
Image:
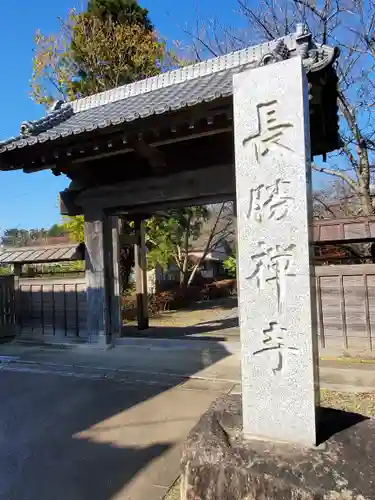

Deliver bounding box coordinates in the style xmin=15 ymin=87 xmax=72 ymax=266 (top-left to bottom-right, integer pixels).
xmin=181 ymin=396 xmax=375 ymax=500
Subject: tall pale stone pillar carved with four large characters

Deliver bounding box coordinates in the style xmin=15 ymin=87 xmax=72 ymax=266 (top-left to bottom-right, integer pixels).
xmin=234 ymin=57 xmax=319 ymax=445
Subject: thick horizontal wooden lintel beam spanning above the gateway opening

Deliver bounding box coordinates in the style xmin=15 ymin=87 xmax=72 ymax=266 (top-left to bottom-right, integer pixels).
xmin=75 ymin=165 xmax=235 ymax=213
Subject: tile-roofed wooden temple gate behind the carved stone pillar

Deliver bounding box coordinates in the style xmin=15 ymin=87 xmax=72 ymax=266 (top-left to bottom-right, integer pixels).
xmin=0 ymin=30 xmax=339 ymax=345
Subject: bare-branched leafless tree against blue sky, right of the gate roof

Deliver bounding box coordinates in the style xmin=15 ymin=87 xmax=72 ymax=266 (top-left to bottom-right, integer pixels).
xmin=184 ymin=0 xmax=375 ymax=215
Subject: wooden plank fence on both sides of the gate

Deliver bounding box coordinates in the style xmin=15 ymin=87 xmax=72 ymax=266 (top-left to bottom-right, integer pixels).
xmin=0 ymin=264 xmax=375 ymax=351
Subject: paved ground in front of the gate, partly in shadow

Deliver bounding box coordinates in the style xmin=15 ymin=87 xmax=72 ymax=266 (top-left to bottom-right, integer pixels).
xmin=0 ymin=339 xmax=375 ymax=500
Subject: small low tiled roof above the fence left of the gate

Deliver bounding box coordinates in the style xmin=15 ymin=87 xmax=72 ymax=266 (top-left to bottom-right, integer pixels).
xmin=0 ymin=245 xmax=82 ymax=264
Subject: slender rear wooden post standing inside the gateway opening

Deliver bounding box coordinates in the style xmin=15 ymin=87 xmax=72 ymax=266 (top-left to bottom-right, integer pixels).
xmin=134 ymin=219 xmax=149 ymax=330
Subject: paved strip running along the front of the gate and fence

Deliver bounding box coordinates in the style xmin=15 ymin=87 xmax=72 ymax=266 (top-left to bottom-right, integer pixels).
xmin=0 ymin=338 xmax=375 ymax=392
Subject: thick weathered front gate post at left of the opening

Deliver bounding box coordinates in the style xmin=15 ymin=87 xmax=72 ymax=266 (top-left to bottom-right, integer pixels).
xmin=85 ymin=210 xmax=120 ymax=346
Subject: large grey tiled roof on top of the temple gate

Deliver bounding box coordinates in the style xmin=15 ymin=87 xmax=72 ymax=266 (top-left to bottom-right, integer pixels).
xmin=0 ymin=28 xmax=336 ymax=154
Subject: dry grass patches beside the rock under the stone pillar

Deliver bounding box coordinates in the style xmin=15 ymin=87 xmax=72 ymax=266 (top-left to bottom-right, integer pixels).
xmin=164 ymin=389 xmax=375 ymax=500
